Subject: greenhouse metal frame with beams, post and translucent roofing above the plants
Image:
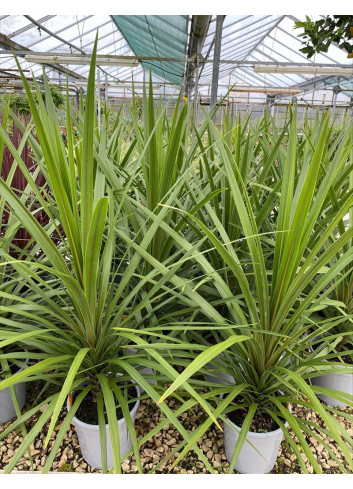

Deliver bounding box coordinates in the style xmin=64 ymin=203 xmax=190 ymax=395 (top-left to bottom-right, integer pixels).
xmin=0 ymin=15 xmax=353 ymax=117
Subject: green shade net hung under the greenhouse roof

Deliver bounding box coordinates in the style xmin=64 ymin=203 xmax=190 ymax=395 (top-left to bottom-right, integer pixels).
xmin=111 ymin=15 xmax=189 ymax=84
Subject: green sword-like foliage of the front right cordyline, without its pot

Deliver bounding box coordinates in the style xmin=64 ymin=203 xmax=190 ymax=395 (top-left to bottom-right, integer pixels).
xmin=151 ymin=112 xmax=353 ymax=473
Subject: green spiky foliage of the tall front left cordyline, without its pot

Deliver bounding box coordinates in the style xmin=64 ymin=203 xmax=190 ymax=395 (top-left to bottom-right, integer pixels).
xmin=0 ymin=38 xmax=247 ymax=473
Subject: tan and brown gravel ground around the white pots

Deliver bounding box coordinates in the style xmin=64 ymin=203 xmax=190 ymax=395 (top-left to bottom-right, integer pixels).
xmin=0 ymin=384 xmax=353 ymax=474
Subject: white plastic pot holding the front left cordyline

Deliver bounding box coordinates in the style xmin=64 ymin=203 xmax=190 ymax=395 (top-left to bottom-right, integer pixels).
xmin=67 ymin=384 xmax=141 ymax=469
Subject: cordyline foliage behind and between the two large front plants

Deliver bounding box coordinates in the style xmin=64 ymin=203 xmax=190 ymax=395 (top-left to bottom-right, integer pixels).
xmin=84 ymin=74 xmax=228 ymax=316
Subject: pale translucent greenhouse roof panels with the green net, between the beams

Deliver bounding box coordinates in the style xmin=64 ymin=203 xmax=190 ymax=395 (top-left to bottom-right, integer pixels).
xmin=0 ymin=15 xmax=353 ymax=95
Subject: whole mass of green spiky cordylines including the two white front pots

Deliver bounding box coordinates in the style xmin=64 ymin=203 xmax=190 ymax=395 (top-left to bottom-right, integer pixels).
xmin=0 ymin=41 xmax=353 ymax=473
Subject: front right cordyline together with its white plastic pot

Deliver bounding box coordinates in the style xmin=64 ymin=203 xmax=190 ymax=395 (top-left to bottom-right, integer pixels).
xmin=153 ymin=110 xmax=353 ymax=473
